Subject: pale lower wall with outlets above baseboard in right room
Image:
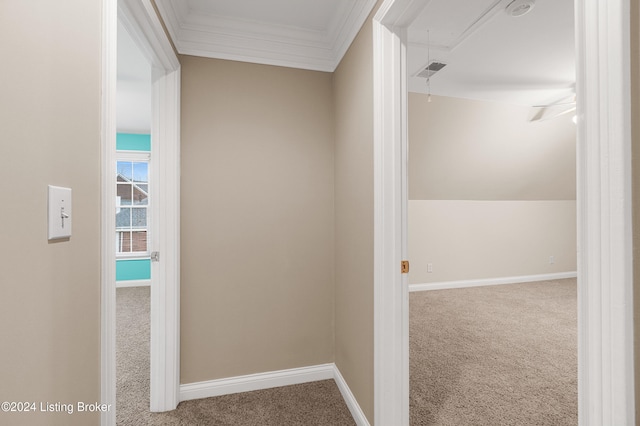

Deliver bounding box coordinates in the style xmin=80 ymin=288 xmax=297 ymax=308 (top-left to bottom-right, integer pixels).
xmin=409 ymin=200 xmax=576 ymax=284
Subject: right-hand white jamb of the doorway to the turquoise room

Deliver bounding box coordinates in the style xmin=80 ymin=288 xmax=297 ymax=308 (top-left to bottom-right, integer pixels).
xmin=150 ymin=68 xmax=180 ymax=411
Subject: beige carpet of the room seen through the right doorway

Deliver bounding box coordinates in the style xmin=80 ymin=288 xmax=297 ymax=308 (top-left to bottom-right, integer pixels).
xmin=410 ymin=279 xmax=578 ymax=426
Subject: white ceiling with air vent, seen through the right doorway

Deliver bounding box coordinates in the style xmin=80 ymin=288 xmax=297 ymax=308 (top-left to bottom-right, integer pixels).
xmin=407 ymin=0 xmax=575 ymax=106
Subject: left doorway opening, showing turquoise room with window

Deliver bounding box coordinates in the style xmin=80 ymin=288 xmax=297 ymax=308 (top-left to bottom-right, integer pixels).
xmin=114 ymin=20 xmax=154 ymax=424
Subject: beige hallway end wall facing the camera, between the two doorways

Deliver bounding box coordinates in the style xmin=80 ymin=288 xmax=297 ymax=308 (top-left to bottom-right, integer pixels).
xmin=180 ymin=56 xmax=334 ymax=383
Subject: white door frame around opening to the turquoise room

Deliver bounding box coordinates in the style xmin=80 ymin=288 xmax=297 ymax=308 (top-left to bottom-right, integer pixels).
xmin=100 ymin=0 xmax=180 ymax=426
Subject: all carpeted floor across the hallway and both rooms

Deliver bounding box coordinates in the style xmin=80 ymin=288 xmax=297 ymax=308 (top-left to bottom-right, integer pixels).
xmin=117 ymin=279 xmax=577 ymax=426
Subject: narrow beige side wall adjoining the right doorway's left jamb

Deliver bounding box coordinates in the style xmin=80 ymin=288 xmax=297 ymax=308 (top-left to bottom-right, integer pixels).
xmin=333 ymin=2 xmax=380 ymax=424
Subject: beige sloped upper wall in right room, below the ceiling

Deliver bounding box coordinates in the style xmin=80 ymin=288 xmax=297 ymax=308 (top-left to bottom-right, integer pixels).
xmin=409 ymin=93 xmax=576 ymax=200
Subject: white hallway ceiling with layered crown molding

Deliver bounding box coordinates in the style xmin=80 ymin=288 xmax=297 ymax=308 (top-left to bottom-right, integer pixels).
xmin=156 ymin=0 xmax=375 ymax=72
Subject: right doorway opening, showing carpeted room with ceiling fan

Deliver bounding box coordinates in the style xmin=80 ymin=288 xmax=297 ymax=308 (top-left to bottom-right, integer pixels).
xmin=407 ymin=0 xmax=578 ymax=424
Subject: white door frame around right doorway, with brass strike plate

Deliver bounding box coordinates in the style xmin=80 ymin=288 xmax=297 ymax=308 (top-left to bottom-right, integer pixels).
xmin=373 ymin=0 xmax=635 ymax=426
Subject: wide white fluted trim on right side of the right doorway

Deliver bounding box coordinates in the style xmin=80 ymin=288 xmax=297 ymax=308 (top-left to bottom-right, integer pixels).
xmin=576 ymin=0 xmax=635 ymax=426
